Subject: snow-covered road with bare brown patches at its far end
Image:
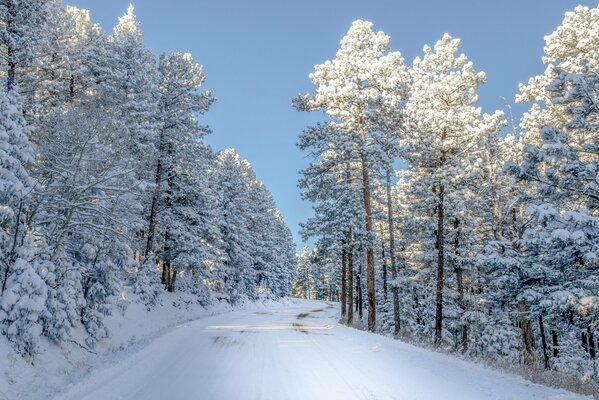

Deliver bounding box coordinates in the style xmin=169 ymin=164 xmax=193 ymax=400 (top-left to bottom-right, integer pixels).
xmin=58 ymin=300 xmax=582 ymax=400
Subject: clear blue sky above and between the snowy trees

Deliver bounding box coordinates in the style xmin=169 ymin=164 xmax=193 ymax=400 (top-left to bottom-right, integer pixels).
xmin=63 ymin=0 xmax=597 ymax=245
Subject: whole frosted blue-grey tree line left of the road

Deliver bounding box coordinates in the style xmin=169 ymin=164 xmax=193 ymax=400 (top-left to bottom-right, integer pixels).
xmin=0 ymin=0 xmax=295 ymax=356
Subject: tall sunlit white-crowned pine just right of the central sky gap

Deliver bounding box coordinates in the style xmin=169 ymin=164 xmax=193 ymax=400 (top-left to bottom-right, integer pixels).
xmin=299 ymin=20 xmax=405 ymax=330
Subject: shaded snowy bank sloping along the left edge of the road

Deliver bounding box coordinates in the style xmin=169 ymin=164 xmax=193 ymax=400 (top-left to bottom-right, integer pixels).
xmin=0 ymin=293 xmax=288 ymax=400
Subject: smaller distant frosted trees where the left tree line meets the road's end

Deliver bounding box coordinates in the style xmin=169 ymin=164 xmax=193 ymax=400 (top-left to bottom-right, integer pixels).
xmin=214 ymin=149 xmax=295 ymax=301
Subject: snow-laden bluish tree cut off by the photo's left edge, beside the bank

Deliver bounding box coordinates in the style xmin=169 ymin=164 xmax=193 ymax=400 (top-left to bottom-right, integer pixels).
xmin=0 ymin=86 xmax=53 ymax=355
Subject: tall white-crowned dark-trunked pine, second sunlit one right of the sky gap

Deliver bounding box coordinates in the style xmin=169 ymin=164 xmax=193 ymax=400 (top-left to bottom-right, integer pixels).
xmin=403 ymin=34 xmax=503 ymax=343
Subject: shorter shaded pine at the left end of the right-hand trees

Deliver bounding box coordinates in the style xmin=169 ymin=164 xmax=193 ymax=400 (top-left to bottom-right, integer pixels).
xmin=298 ymin=124 xmax=366 ymax=324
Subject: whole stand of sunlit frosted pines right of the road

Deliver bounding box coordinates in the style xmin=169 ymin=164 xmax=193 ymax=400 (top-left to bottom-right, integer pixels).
xmin=294 ymin=6 xmax=599 ymax=388
